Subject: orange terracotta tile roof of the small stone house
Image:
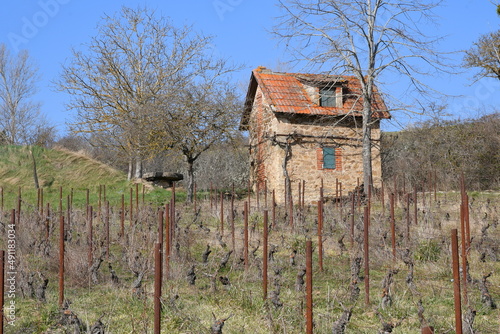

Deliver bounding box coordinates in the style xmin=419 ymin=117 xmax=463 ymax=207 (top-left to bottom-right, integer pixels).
xmin=242 ymin=67 xmax=390 ymax=126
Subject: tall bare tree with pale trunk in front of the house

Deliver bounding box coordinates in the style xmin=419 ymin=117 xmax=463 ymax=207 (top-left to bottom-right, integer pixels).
xmin=274 ymin=0 xmax=444 ymax=191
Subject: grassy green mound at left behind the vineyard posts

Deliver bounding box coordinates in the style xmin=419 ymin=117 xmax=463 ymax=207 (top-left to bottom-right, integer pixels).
xmin=0 ymin=146 xmax=170 ymax=208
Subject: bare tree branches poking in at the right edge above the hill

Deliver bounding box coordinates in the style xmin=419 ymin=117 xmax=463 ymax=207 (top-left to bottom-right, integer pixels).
xmin=464 ymin=30 xmax=500 ymax=80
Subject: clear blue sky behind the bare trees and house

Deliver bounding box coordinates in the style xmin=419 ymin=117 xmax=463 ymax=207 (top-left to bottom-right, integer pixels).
xmin=0 ymin=0 xmax=500 ymax=134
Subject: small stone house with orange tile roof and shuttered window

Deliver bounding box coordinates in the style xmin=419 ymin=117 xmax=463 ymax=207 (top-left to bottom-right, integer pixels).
xmin=240 ymin=67 xmax=390 ymax=203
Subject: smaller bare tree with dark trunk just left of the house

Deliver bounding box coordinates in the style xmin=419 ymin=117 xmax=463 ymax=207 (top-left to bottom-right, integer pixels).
xmin=158 ymin=76 xmax=241 ymax=201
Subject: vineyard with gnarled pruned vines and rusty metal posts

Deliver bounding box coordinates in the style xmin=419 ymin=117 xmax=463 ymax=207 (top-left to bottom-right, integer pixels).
xmin=0 ymin=147 xmax=500 ymax=334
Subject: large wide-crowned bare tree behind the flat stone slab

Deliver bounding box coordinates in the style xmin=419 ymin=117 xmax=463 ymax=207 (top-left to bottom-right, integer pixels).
xmin=57 ymin=7 xmax=219 ymax=177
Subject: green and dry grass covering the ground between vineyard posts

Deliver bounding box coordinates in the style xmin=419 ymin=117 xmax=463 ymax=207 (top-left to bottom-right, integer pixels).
xmin=0 ymin=148 xmax=500 ymax=334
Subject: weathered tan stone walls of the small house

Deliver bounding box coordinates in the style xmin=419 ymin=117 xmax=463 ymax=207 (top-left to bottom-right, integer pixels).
xmin=242 ymin=68 xmax=388 ymax=203
